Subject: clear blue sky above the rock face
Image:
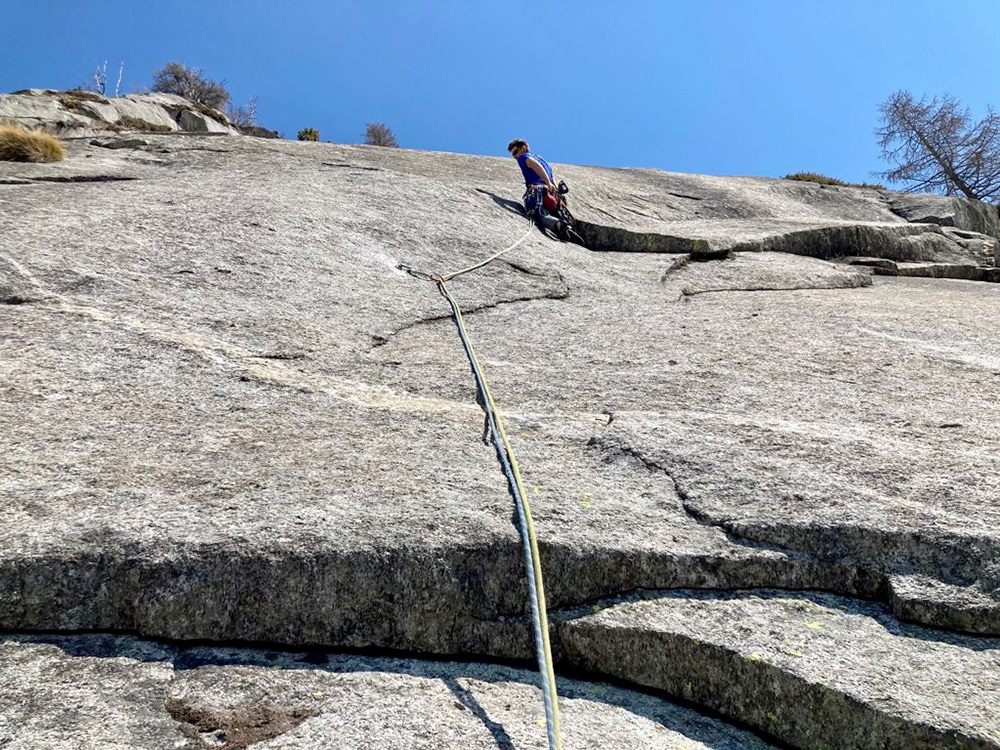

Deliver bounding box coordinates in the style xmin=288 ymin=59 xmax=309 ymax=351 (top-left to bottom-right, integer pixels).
xmin=0 ymin=0 xmax=1000 ymax=181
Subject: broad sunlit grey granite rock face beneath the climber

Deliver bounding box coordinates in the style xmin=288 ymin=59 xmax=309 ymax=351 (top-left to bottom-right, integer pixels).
xmin=0 ymin=134 xmax=1000 ymax=748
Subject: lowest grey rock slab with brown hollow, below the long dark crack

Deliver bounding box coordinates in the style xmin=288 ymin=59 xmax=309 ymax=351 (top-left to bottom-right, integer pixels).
xmin=0 ymin=635 xmax=771 ymax=750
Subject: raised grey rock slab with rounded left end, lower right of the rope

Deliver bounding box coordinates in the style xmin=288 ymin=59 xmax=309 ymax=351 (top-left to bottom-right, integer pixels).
xmin=558 ymin=591 xmax=1000 ymax=750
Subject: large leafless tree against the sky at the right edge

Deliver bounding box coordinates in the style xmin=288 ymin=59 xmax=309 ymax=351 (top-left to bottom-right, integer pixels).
xmin=875 ymin=91 xmax=1000 ymax=202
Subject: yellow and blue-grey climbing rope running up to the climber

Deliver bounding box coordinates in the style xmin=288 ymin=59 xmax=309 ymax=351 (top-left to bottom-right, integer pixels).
xmin=399 ymin=217 xmax=562 ymax=750
